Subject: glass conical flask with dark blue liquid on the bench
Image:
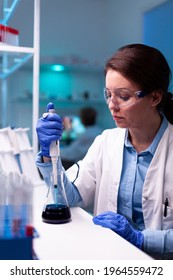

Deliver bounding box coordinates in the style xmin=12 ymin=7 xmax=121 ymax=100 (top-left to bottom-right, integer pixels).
xmin=42 ymin=169 xmax=71 ymax=224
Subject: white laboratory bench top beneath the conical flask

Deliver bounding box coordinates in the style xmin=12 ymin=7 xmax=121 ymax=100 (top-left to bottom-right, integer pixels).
xmin=33 ymin=185 xmax=151 ymax=260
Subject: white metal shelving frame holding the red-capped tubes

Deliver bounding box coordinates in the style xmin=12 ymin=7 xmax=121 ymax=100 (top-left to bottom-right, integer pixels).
xmin=0 ymin=0 xmax=40 ymax=154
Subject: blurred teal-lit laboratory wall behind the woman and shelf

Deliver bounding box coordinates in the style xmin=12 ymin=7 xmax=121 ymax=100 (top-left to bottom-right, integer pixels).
xmin=0 ymin=0 xmax=173 ymax=143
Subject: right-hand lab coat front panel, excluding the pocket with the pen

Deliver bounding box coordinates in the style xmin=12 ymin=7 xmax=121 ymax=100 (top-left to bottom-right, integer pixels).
xmin=142 ymin=125 xmax=173 ymax=229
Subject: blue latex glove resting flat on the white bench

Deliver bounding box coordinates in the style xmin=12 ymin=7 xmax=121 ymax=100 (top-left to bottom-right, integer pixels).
xmin=93 ymin=211 xmax=144 ymax=249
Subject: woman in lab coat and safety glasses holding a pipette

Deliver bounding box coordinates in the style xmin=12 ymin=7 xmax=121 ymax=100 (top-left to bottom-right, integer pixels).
xmin=36 ymin=44 xmax=173 ymax=259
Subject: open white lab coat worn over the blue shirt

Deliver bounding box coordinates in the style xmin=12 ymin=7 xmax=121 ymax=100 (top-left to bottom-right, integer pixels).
xmin=67 ymin=123 xmax=173 ymax=230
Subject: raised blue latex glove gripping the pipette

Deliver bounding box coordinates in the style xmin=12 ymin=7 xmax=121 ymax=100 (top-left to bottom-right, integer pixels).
xmin=36 ymin=103 xmax=63 ymax=157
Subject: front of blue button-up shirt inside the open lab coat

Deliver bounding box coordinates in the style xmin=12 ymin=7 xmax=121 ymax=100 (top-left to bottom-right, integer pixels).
xmin=118 ymin=116 xmax=168 ymax=230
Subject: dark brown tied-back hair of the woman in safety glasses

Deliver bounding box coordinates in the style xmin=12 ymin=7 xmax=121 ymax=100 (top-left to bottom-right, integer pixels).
xmin=105 ymin=44 xmax=173 ymax=123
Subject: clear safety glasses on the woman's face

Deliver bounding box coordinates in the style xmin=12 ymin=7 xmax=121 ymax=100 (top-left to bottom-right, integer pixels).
xmin=104 ymin=87 xmax=147 ymax=108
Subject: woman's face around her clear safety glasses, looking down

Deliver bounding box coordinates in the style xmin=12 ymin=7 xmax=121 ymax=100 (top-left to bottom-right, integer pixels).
xmin=105 ymin=69 xmax=157 ymax=129
